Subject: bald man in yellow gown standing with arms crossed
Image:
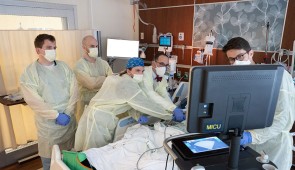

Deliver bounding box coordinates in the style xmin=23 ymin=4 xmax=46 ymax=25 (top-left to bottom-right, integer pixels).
xmin=74 ymin=35 xmax=113 ymax=121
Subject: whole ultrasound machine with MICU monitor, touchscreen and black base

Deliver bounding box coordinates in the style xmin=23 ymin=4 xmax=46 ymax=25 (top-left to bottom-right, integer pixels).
xmin=164 ymin=65 xmax=284 ymax=170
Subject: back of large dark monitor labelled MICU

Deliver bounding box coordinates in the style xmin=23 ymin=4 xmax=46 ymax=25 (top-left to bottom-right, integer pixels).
xmin=187 ymin=65 xmax=284 ymax=134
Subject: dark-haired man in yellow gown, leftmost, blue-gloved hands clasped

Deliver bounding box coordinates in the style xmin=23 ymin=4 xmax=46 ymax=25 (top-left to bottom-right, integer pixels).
xmin=20 ymin=34 xmax=78 ymax=170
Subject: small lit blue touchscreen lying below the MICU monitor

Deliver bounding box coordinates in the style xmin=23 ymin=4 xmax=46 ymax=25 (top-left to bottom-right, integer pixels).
xmin=183 ymin=136 xmax=228 ymax=153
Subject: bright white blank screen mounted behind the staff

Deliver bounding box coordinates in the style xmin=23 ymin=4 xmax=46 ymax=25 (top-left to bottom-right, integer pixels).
xmin=107 ymin=39 xmax=139 ymax=58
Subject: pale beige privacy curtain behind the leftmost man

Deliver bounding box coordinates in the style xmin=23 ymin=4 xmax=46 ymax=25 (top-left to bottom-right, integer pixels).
xmin=0 ymin=30 xmax=94 ymax=152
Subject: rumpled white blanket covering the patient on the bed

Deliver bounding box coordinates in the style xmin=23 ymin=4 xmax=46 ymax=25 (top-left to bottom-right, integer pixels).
xmin=84 ymin=123 xmax=184 ymax=170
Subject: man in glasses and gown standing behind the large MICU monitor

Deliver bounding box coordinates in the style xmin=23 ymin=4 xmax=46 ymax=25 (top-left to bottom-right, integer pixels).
xmin=223 ymin=37 xmax=295 ymax=170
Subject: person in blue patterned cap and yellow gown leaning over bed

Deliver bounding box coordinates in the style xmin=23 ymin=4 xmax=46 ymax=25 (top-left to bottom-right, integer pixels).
xmin=75 ymin=58 xmax=172 ymax=151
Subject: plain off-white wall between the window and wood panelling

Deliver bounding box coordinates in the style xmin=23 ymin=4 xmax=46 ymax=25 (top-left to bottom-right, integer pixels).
xmin=20 ymin=0 xmax=138 ymax=72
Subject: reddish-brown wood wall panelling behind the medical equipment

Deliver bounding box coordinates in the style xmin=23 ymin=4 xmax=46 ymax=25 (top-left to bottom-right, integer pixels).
xmin=139 ymin=0 xmax=295 ymax=70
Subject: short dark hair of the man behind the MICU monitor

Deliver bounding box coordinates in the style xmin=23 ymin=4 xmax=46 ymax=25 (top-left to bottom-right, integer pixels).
xmin=222 ymin=37 xmax=251 ymax=53
